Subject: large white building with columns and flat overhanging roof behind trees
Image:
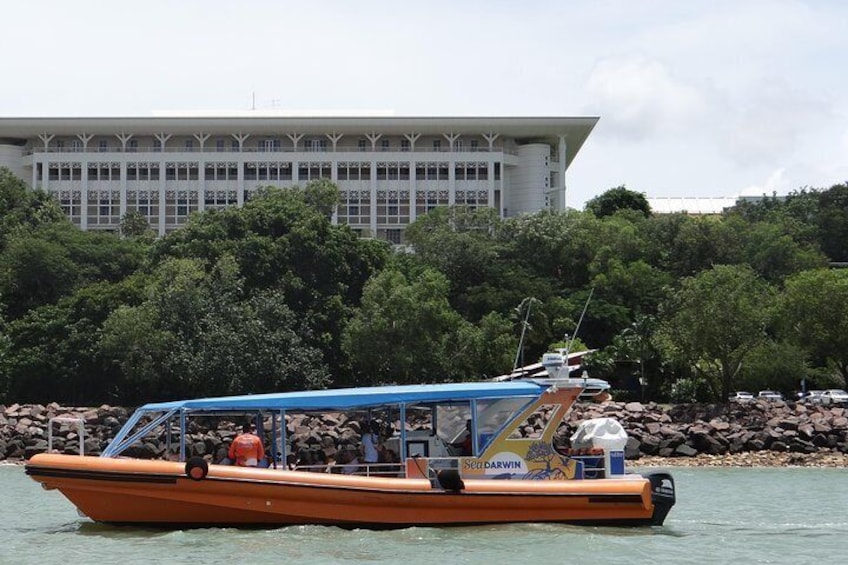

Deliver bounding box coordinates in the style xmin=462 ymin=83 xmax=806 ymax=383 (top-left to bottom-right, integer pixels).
xmin=0 ymin=117 xmax=598 ymax=243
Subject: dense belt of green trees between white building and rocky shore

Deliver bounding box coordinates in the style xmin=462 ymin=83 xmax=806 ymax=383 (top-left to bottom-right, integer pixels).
xmin=0 ymin=164 xmax=848 ymax=405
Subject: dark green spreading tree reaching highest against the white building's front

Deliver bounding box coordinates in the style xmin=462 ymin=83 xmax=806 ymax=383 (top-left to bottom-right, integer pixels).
xmin=153 ymin=183 xmax=391 ymax=375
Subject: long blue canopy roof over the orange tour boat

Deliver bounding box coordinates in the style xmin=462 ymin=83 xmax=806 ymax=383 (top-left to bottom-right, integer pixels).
xmin=139 ymin=381 xmax=548 ymax=412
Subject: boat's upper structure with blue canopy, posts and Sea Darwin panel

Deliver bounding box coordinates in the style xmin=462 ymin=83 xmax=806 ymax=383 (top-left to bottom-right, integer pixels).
xmin=96 ymin=379 xmax=626 ymax=479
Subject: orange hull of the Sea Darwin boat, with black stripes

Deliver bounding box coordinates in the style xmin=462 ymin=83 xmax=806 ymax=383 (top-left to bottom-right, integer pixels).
xmin=26 ymin=454 xmax=665 ymax=529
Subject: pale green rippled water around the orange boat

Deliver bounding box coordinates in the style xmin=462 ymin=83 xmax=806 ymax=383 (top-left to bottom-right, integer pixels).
xmin=0 ymin=466 xmax=848 ymax=565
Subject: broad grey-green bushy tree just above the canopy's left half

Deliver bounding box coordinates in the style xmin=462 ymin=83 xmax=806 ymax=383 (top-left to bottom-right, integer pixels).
xmin=99 ymin=255 xmax=328 ymax=401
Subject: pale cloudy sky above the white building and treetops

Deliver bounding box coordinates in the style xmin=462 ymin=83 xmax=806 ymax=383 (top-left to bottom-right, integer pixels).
xmin=0 ymin=0 xmax=848 ymax=208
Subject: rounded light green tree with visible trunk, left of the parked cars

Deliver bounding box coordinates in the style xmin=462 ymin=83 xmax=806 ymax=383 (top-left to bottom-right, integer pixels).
xmin=657 ymin=265 xmax=774 ymax=400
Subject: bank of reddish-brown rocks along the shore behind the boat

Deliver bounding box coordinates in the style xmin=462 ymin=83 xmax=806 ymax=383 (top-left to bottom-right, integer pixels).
xmin=0 ymin=401 xmax=848 ymax=467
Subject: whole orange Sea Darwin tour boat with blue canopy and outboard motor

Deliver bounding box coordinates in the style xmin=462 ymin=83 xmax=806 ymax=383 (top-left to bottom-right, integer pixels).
xmin=26 ymin=378 xmax=675 ymax=529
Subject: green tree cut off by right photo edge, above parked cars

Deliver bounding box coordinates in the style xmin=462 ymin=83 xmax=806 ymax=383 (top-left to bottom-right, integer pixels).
xmin=778 ymin=269 xmax=848 ymax=388
